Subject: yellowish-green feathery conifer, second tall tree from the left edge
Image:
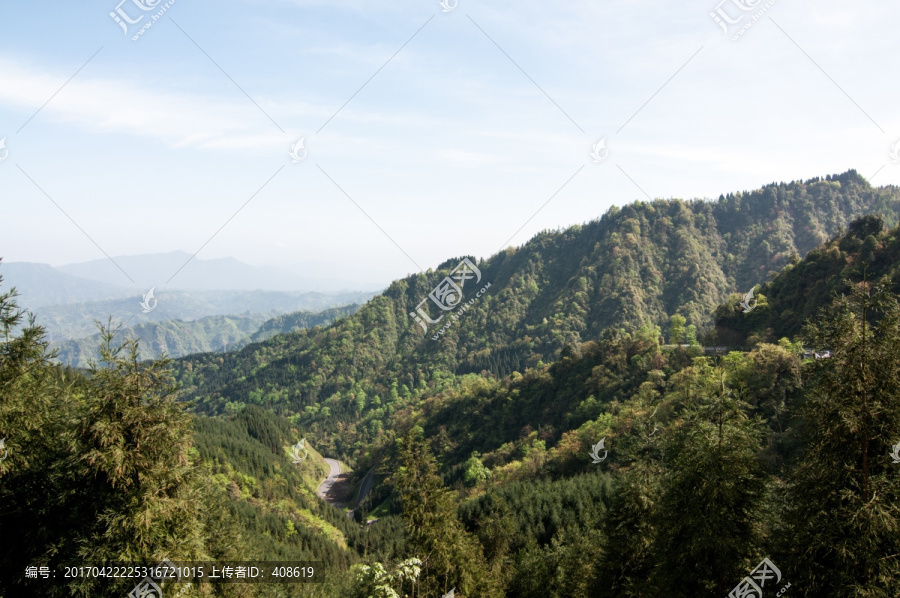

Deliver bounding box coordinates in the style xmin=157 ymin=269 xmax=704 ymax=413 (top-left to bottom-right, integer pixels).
xmin=72 ymin=328 xmax=207 ymax=572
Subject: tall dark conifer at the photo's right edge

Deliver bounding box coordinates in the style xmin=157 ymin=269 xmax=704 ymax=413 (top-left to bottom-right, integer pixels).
xmin=783 ymin=283 xmax=900 ymax=598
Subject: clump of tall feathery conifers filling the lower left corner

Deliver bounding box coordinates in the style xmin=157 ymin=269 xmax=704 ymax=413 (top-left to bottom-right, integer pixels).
xmin=0 ymin=293 xmax=206 ymax=595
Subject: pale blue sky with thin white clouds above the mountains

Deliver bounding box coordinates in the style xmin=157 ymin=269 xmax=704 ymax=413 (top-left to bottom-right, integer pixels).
xmin=0 ymin=0 xmax=900 ymax=286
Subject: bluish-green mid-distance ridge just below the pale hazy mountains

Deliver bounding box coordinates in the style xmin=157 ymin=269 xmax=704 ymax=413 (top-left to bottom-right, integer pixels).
xmin=51 ymin=305 xmax=359 ymax=367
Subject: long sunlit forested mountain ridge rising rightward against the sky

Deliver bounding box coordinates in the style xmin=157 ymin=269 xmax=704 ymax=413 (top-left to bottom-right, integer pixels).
xmin=177 ymin=171 xmax=900 ymax=437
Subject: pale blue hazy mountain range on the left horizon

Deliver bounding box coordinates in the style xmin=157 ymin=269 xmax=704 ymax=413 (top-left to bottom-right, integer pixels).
xmin=0 ymin=251 xmax=374 ymax=344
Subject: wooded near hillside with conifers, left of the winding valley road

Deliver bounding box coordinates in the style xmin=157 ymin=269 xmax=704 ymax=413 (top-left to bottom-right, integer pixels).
xmin=0 ymin=292 xmax=403 ymax=598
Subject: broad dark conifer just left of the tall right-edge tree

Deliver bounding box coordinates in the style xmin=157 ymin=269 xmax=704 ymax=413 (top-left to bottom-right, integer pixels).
xmin=653 ymin=357 xmax=765 ymax=598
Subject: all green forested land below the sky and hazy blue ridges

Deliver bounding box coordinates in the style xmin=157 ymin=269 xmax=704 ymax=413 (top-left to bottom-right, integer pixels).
xmin=0 ymin=172 xmax=900 ymax=598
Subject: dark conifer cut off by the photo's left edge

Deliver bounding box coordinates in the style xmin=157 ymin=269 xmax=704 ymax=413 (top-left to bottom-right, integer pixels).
xmin=0 ymin=277 xmax=81 ymax=595
